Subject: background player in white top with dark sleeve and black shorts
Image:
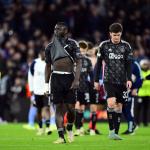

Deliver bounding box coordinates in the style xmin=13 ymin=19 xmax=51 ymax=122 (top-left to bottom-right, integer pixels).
xmin=28 ymin=49 xmax=51 ymax=135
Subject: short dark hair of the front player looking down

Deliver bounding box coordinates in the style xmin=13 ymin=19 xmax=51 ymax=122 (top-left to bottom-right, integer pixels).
xmin=109 ymin=23 xmax=123 ymax=33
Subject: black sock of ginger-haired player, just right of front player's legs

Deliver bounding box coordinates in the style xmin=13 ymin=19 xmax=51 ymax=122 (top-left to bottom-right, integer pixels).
xmin=75 ymin=111 xmax=83 ymax=129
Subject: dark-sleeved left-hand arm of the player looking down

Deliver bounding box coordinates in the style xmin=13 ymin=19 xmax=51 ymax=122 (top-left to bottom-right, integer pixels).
xmin=94 ymin=45 xmax=103 ymax=90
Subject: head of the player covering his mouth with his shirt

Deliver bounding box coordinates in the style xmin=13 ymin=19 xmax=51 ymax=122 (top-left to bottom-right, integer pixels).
xmin=54 ymin=25 xmax=68 ymax=37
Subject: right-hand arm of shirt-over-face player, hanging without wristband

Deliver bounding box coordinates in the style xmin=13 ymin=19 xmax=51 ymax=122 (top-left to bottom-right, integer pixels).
xmin=71 ymin=43 xmax=82 ymax=89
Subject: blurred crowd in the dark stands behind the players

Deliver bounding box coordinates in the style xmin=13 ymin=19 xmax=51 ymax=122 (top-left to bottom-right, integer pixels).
xmin=0 ymin=0 xmax=150 ymax=121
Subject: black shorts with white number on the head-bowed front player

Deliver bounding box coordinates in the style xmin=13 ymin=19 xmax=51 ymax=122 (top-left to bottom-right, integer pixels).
xmin=104 ymin=83 xmax=128 ymax=103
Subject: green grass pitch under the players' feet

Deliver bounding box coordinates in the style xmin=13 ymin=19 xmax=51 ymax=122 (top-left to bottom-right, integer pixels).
xmin=0 ymin=123 xmax=150 ymax=150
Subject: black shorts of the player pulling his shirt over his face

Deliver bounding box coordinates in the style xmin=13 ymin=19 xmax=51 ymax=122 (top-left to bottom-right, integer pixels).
xmin=51 ymin=73 xmax=76 ymax=104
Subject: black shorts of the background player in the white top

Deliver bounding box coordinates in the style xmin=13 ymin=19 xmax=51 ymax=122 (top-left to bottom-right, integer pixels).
xmin=34 ymin=95 xmax=50 ymax=109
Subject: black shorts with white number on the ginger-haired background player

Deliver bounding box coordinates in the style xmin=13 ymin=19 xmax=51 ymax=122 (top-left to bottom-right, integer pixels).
xmin=77 ymin=91 xmax=90 ymax=105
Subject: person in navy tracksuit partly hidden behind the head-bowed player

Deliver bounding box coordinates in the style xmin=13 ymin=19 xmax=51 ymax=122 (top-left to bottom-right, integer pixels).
xmin=122 ymin=51 xmax=142 ymax=135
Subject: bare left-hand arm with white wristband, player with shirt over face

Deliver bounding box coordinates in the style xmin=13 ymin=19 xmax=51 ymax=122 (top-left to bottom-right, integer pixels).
xmin=45 ymin=44 xmax=51 ymax=94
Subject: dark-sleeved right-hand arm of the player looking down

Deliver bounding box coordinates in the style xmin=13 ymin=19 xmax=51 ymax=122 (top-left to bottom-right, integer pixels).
xmin=125 ymin=44 xmax=133 ymax=89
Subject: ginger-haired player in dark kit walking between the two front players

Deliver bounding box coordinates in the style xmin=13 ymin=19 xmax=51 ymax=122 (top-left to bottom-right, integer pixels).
xmin=74 ymin=41 xmax=94 ymax=136
